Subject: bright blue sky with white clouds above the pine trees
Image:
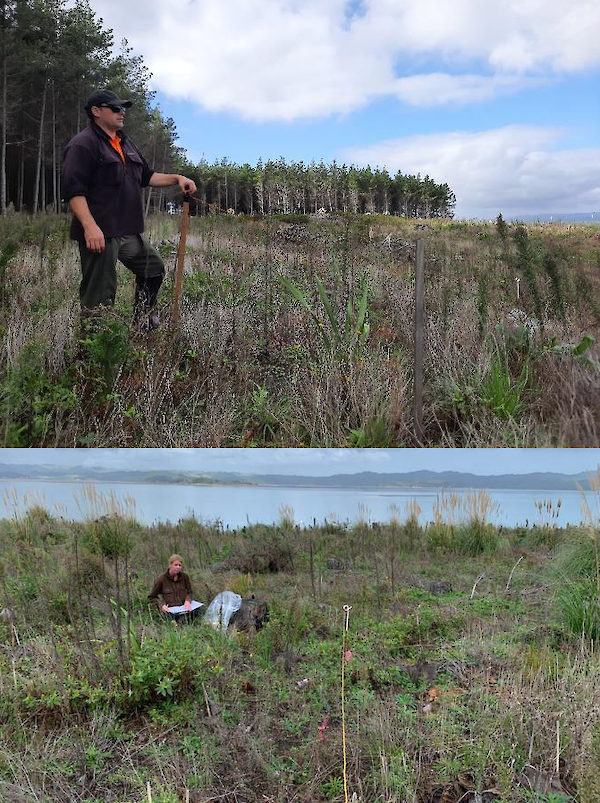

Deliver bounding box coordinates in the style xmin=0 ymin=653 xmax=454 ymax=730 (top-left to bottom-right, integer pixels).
xmin=91 ymin=0 xmax=600 ymax=218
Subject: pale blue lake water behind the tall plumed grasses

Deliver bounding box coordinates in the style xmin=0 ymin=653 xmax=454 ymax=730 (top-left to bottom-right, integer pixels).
xmin=0 ymin=481 xmax=594 ymax=529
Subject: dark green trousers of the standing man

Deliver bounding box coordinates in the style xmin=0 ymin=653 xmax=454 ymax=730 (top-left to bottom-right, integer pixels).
xmin=79 ymin=234 xmax=165 ymax=310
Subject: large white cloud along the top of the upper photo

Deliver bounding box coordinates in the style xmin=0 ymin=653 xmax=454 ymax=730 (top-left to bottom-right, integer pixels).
xmin=86 ymin=0 xmax=600 ymax=120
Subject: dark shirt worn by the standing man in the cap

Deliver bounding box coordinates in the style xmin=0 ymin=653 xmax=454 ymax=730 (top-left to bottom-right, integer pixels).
xmin=61 ymin=123 xmax=154 ymax=242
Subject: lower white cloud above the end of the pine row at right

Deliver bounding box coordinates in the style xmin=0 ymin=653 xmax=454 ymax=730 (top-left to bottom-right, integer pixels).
xmin=343 ymin=126 xmax=600 ymax=218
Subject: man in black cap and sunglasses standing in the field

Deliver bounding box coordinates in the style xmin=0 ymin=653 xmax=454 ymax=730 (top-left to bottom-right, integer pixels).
xmin=62 ymin=89 xmax=196 ymax=329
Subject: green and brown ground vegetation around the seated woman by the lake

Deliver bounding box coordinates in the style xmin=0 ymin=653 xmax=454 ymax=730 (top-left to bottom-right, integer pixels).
xmin=0 ymin=489 xmax=600 ymax=803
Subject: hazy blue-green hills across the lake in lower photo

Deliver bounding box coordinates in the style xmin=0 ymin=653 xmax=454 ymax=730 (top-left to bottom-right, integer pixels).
xmin=0 ymin=463 xmax=590 ymax=491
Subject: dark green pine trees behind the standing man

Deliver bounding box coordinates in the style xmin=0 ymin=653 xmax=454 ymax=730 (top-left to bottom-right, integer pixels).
xmin=0 ymin=0 xmax=456 ymax=217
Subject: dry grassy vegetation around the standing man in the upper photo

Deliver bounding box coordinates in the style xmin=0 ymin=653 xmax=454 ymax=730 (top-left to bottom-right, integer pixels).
xmin=0 ymin=213 xmax=600 ymax=447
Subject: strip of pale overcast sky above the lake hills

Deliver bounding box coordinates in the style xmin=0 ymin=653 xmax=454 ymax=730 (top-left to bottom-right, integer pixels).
xmin=0 ymin=449 xmax=600 ymax=476
